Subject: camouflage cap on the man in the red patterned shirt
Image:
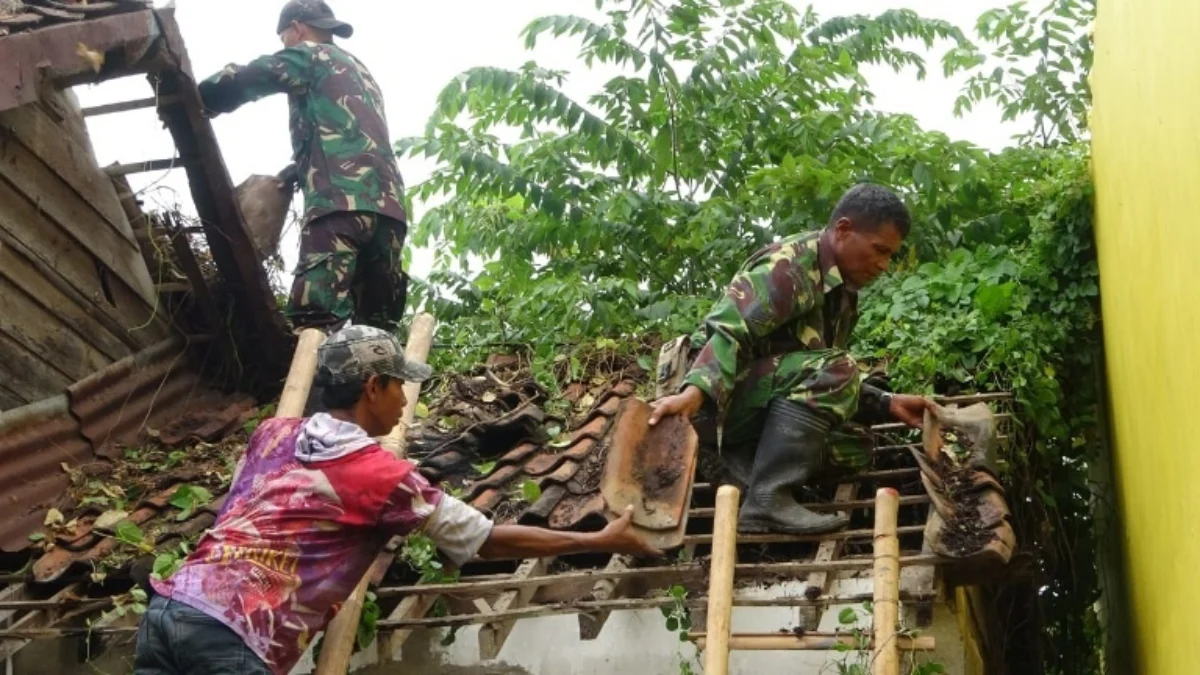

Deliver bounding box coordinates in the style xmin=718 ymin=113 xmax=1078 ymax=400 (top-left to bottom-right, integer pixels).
xmin=317 ymin=325 xmax=433 ymax=386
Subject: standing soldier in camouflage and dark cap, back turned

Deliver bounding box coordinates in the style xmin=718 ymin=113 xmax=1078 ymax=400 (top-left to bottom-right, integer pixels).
xmin=199 ymin=0 xmax=407 ymax=330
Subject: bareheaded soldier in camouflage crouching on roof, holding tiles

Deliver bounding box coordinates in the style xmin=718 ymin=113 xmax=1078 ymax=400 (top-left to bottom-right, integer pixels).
xmin=650 ymin=184 xmax=928 ymax=534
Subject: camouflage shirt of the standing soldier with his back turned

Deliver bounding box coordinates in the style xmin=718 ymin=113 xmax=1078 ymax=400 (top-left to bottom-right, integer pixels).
xmin=199 ymin=42 xmax=406 ymax=223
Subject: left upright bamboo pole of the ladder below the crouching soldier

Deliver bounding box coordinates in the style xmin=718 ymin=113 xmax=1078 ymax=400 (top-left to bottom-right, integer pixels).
xmin=704 ymin=485 xmax=739 ymax=675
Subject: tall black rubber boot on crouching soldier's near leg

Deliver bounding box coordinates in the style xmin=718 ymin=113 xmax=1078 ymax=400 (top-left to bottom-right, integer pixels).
xmin=738 ymin=399 xmax=850 ymax=534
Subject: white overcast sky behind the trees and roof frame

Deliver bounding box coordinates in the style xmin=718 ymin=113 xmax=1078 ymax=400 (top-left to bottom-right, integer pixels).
xmin=77 ymin=0 xmax=1018 ymax=275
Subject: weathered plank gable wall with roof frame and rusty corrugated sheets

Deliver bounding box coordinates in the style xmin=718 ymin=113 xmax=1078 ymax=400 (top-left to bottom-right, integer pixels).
xmin=0 ymin=0 xmax=289 ymax=551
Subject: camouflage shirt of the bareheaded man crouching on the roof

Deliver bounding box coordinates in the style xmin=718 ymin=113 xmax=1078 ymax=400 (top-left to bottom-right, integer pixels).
xmin=684 ymin=232 xmax=858 ymax=411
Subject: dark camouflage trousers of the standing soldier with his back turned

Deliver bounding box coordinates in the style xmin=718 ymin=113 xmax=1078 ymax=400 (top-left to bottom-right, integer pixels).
xmin=287 ymin=211 xmax=408 ymax=330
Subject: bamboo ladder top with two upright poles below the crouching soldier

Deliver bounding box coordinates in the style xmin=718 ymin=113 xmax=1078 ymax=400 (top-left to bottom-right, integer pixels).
xmin=690 ymin=485 xmax=934 ymax=675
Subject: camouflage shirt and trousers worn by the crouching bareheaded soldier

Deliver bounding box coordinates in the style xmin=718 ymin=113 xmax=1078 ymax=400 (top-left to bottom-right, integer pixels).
xmin=684 ymin=232 xmax=880 ymax=468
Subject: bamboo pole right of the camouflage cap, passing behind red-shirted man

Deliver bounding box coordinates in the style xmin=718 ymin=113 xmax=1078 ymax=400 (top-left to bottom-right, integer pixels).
xmin=316 ymin=313 xmax=434 ymax=675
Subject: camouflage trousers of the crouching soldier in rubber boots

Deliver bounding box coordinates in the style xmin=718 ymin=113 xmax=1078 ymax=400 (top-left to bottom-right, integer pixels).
xmin=694 ymin=350 xmax=874 ymax=477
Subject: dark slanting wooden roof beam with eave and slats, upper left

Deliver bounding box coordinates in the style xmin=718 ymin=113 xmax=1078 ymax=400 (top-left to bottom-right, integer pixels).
xmin=0 ymin=0 xmax=290 ymax=372
